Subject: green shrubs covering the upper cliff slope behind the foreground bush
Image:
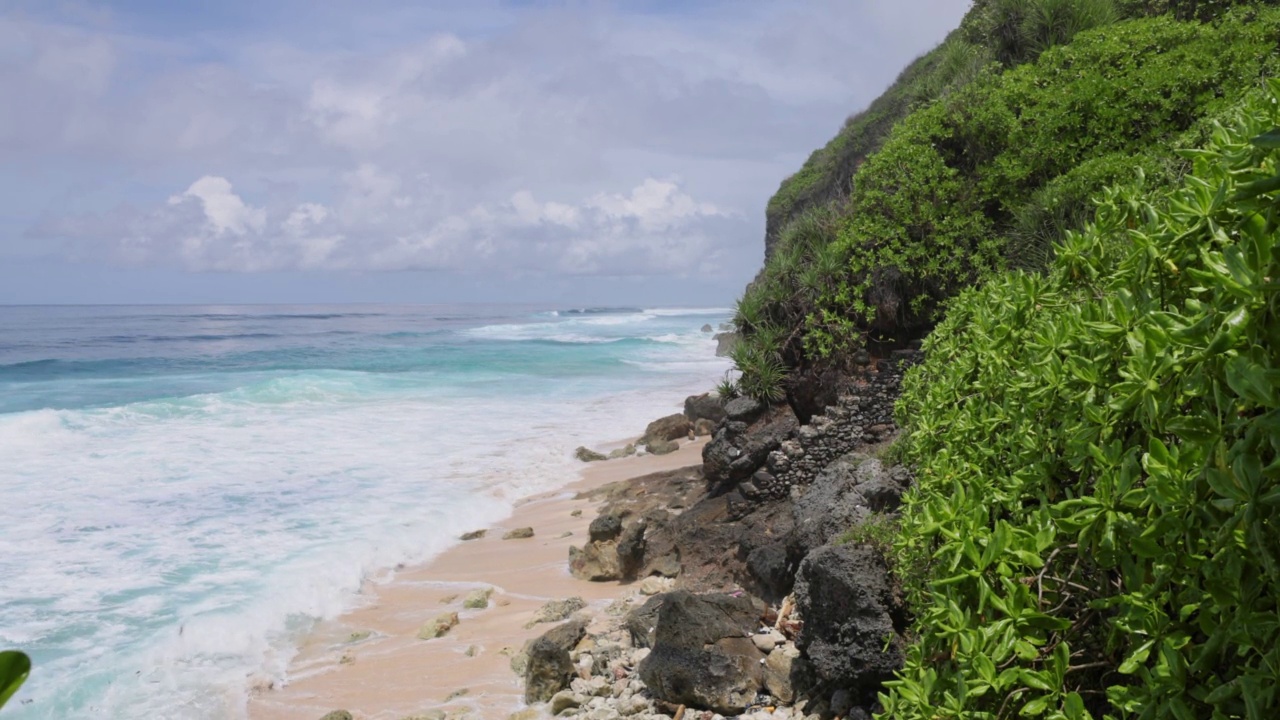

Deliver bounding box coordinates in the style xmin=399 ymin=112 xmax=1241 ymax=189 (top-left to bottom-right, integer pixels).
xmin=737 ymin=0 xmax=1280 ymax=396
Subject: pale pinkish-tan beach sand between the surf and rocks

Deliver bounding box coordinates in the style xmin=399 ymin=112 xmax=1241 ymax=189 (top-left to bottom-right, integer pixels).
xmin=248 ymin=438 xmax=707 ymax=720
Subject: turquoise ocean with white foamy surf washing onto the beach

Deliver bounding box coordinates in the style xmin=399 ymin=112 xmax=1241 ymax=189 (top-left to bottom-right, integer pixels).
xmin=0 ymin=305 xmax=728 ymax=720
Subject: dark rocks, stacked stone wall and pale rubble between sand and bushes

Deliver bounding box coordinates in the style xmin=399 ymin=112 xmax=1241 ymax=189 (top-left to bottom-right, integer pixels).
xmin=501 ymin=350 xmax=918 ymax=720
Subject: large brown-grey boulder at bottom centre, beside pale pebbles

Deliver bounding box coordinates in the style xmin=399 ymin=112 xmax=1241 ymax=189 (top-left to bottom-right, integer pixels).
xmin=628 ymin=591 xmax=764 ymax=715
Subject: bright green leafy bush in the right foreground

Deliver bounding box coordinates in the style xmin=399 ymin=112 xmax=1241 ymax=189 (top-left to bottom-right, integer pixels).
xmin=882 ymin=82 xmax=1280 ymax=720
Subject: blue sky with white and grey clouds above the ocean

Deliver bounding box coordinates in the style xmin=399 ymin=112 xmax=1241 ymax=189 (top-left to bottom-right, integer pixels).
xmin=0 ymin=0 xmax=968 ymax=305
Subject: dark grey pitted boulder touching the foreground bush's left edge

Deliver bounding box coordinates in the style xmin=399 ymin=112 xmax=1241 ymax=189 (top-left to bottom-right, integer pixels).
xmin=796 ymin=546 xmax=905 ymax=700
